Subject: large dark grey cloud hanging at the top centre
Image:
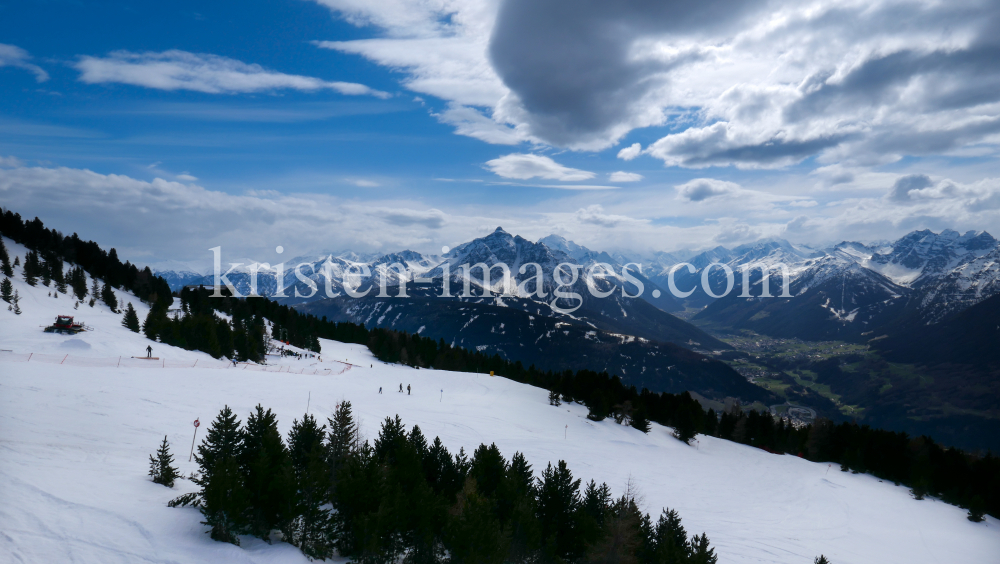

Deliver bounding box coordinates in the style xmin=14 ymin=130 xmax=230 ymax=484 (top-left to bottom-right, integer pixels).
xmin=490 ymin=0 xmax=753 ymax=146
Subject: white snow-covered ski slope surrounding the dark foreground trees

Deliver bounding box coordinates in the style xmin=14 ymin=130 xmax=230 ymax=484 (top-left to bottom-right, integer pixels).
xmin=0 ymin=251 xmax=1000 ymax=564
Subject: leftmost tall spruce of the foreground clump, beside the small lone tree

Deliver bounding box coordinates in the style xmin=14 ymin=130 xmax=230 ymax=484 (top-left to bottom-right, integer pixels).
xmin=194 ymin=405 xmax=247 ymax=545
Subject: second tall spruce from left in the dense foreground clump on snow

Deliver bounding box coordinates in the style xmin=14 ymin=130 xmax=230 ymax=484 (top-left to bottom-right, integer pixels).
xmin=240 ymin=404 xmax=295 ymax=542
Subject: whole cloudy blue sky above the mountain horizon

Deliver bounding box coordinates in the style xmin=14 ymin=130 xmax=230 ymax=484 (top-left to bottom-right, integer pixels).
xmin=0 ymin=0 xmax=1000 ymax=266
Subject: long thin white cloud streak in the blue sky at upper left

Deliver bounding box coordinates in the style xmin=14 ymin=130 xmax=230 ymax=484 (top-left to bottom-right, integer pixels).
xmin=74 ymin=50 xmax=389 ymax=98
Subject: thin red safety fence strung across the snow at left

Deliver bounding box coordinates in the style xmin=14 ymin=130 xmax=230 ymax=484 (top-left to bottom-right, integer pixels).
xmin=0 ymin=351 xmax=351 ymax=375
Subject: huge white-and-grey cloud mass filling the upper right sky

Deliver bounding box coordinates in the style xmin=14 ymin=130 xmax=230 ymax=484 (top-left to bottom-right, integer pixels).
xmin=317 ymin=0 xmax=1000 ymax=168
